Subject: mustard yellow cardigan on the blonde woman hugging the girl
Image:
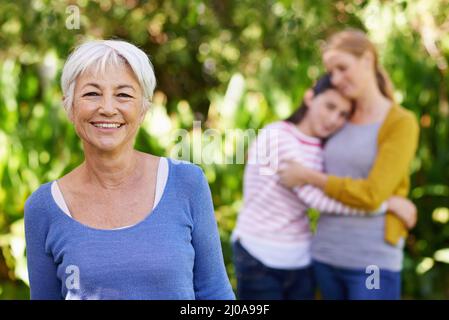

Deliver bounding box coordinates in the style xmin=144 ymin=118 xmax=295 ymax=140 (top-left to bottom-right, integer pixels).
xmin=325 ymin=105 xmax=419 ymax=245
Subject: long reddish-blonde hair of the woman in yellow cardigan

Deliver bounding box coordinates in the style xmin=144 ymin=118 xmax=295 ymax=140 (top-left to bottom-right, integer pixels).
xmin=323 ymin=29 xmax=394 ymax=101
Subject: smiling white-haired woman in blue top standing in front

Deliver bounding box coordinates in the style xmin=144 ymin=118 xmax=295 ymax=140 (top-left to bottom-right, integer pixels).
xmin=25 ymin=40 xmax=234 ymax=299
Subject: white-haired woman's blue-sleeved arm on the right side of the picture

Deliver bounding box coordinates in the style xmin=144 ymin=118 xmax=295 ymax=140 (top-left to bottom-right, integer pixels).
xmin=190 ymin=167 xmax=235 ymax=300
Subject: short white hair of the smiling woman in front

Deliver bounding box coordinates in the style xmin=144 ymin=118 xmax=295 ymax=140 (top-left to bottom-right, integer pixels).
xmin=61 ymin=40 xmax=156 ymax=112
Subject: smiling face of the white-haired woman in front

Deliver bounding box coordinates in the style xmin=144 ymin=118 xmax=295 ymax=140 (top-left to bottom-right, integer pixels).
xmin=69 ymin=63 xmax=145 ymax=152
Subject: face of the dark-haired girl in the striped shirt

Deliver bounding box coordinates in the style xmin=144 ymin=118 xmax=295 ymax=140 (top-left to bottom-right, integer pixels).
xmin=303 ymin=89 xmax=352 ymax=138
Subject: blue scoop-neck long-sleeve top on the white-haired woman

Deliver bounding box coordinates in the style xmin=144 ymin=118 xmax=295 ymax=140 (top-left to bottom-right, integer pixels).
xmin=25 ymin=159 xmax=235 ymax=300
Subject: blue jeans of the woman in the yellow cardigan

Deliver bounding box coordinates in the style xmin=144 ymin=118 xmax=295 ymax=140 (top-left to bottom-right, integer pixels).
xmin=313 ymin=261 xmax=401 ymax=300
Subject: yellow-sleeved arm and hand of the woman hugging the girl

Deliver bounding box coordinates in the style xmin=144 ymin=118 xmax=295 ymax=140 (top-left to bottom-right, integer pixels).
xmin=279 ymin=107 xmax=419 ymax=230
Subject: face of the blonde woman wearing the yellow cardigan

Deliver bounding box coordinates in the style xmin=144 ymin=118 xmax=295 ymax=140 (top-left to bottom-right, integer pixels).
xmin=323 ymin=49 xmax=373 ymax=99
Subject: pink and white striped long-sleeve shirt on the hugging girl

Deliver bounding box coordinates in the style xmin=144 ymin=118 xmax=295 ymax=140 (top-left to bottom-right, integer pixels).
xmin=233 ymin=121 xmax=383 ymax=267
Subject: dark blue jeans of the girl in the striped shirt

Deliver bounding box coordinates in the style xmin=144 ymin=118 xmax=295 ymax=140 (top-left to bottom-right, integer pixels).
xmin=232 ymin=241 xmax=315 ymax=300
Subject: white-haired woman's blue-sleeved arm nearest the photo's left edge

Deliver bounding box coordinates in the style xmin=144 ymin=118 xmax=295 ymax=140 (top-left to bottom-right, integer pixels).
xmin=25 ymin=195 xmax=63 ymax=300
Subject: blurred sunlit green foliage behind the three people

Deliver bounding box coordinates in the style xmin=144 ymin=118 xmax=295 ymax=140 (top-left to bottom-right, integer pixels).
xmin=0 ymin=0 xmax=449 ymax=299
